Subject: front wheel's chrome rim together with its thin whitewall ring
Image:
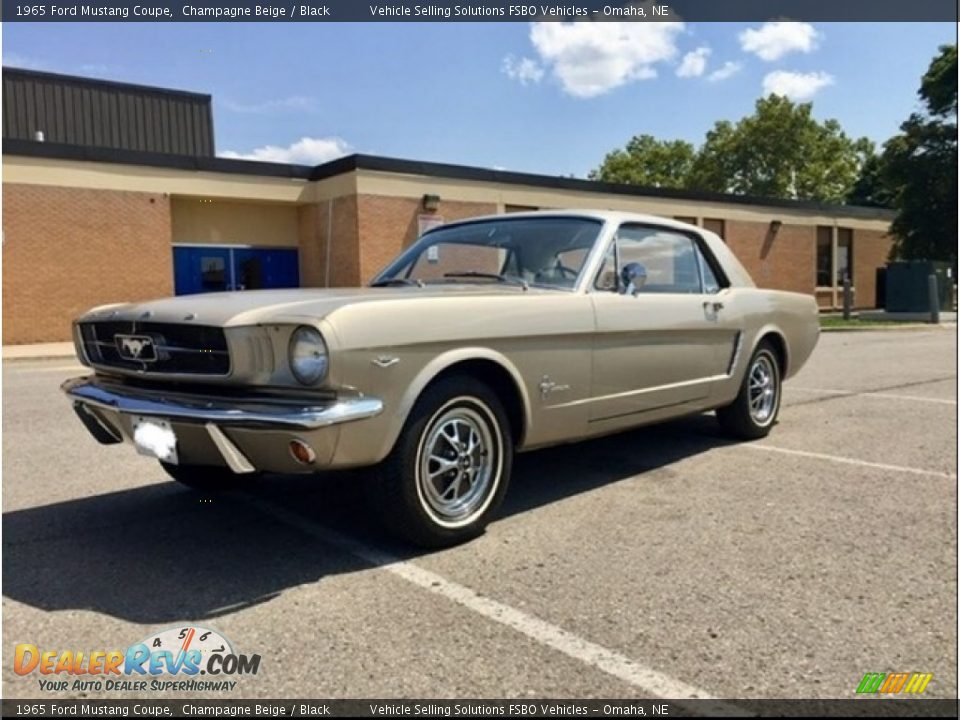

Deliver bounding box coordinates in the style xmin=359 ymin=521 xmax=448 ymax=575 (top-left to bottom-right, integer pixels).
xmin=417 ymin=396 xmax=503 ymax=528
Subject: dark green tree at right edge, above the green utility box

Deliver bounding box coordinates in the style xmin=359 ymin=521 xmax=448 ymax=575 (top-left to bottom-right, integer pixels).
xmin=882 ymin=45 xmax=957 ymax=267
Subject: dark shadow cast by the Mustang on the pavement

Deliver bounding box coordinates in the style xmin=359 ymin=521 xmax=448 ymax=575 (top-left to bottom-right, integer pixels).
xmin=3 ymin=416 xmax=728 ymax=624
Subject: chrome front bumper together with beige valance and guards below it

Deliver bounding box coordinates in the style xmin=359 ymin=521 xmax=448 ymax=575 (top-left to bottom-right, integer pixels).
xmin=61 ymin=376 xmax=383 ymax=473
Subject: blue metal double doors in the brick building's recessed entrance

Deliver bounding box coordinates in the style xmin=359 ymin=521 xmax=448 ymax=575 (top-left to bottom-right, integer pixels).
xmin=173 ymin=245 xmax=300 ymax=295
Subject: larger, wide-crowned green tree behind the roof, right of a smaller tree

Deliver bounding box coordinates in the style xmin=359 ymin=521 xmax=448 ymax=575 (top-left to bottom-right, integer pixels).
xmin=686 ymin=95 xmax=873 ymax=202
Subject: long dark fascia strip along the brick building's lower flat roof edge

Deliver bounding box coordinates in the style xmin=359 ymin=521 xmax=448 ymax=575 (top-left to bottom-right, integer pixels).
xmin=3 ymin=139 xmax=896 ymax=221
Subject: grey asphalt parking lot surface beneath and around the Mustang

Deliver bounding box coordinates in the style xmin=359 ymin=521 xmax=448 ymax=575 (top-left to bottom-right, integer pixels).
xmin=2 ymin=327 xmax=957 ymax=698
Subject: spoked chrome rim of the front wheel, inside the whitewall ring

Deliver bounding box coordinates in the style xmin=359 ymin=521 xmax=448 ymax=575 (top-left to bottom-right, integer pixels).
xmin=417 ymin=407 xmax=496 ymax=522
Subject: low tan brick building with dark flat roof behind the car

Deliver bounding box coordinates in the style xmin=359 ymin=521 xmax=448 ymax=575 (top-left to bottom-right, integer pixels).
xmin=2 ymin=70 xmax=892 ymax=344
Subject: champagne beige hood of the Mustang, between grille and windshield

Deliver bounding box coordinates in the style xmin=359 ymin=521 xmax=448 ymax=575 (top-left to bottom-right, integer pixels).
xmin=79 ymin=283 xmax=540 ymax=327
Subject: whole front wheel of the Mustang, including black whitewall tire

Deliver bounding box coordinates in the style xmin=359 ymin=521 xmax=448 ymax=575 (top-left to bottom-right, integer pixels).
xmin=367 ymin=376 xmax=513 ymax=548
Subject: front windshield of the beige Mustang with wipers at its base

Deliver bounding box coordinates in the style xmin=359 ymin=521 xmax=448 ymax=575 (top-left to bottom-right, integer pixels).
xmin=372 ymin=217 xmax=601 ymax=290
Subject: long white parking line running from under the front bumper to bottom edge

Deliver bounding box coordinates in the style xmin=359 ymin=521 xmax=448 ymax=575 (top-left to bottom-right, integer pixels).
xmin=238 ymin=495 xmax=742 ymax=714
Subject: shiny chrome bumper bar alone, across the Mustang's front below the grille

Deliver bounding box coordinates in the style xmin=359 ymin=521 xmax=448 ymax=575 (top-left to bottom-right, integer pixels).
xmin=60 ymin=377 xmax=383 ymax=430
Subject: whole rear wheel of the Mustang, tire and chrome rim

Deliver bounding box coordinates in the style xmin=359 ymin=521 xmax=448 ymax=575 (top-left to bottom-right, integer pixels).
xmin=717 ymin=341 xmax=781 ymax=440
